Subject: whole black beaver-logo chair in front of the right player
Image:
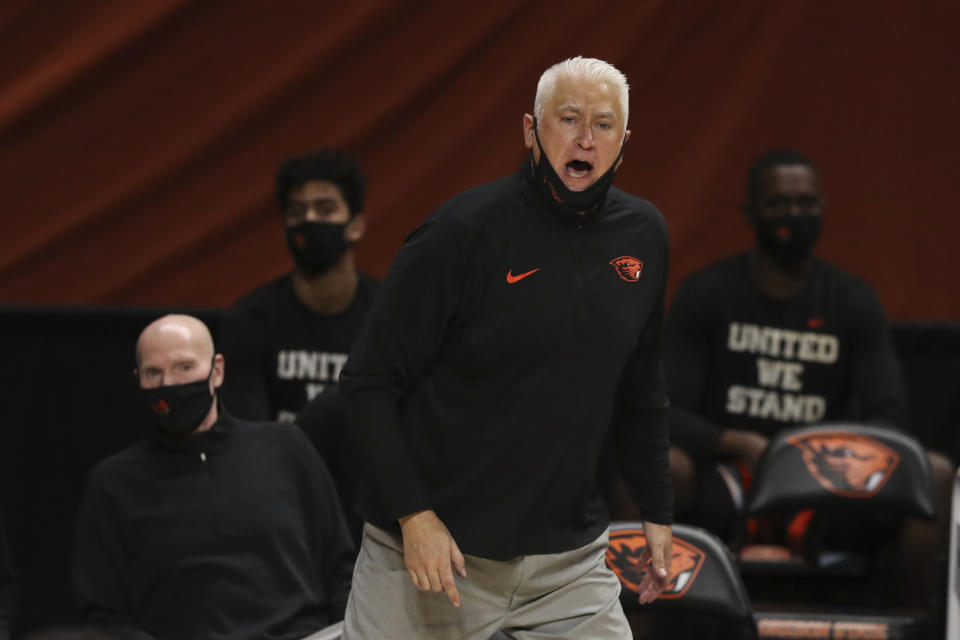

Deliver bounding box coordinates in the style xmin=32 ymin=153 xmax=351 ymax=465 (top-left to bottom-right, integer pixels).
xmin=738 ymin=423 xmax=936 ymax=638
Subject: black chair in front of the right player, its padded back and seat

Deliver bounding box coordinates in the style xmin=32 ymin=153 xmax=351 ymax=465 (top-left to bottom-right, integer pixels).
xmin=738 ymin=423 xmax=935 ymax=639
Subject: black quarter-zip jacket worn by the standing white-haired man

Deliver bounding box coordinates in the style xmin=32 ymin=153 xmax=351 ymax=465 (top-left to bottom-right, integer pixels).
xmin=341 ymin=159 xmax=672 ymax=559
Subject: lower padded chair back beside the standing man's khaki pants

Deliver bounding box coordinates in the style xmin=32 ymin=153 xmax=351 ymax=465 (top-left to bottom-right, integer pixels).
xmin=606 ymin=522 xmax=753 ymax=624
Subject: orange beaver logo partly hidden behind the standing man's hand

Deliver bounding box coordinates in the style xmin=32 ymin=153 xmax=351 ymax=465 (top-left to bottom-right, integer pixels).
xmin=606 ymin=529 xmax=706 ymax=598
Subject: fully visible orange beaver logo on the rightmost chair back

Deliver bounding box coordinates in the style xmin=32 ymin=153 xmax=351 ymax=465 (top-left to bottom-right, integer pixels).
xmin=787 ymin=431 xmax=900 ymax=498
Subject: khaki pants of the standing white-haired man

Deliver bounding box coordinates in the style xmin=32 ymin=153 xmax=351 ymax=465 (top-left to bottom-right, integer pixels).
xmin=343 ymin=524 xmax=632 ymax=640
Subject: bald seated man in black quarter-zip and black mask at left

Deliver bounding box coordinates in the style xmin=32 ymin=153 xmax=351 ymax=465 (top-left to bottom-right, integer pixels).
xmin=74 ymin=315 xmax=354 ymax=640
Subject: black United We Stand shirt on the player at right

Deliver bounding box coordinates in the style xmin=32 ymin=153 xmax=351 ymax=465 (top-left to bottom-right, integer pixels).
xmin=664 ymin=254 xmax=907 ymax=458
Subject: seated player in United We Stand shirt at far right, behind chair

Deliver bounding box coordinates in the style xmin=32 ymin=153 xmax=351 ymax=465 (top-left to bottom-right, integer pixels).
xmin=664 ymin=149 xmax=952 ymax=612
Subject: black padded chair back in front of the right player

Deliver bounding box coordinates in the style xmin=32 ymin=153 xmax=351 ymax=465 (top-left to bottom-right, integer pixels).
xmin=746 ymin=423 xmax=935 ymax=519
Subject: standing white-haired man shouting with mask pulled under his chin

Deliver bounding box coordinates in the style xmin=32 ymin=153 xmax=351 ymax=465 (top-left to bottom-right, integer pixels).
xmin=341 ymin=57 xmax=672 ymax=640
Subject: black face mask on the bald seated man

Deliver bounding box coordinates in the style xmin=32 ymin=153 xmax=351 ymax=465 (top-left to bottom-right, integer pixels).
xmin=140 ymin=365 xmax=213 ymax=440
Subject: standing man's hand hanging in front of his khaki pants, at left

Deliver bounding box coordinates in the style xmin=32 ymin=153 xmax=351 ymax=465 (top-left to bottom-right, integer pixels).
xmin=399 ymin=509 xmax=467 ymax=607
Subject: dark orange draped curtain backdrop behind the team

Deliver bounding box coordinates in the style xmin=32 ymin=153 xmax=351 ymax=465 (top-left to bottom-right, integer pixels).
xmin=0 ymin=0 xmax=960 ymax=319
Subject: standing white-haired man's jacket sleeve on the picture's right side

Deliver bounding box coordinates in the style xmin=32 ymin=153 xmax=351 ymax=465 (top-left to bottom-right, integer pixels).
xmin=611 ymin=225 xmax=673 ymax=524
